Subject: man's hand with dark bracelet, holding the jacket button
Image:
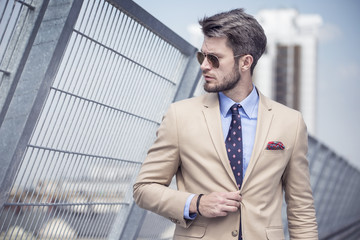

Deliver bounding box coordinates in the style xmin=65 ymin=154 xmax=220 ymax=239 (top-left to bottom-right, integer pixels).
xmin=190 ymin=191 xmax=242 ymax=218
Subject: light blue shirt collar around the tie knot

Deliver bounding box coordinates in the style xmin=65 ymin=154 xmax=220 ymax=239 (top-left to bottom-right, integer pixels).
xmin=219 ymin=85 xmax=259 ymax=118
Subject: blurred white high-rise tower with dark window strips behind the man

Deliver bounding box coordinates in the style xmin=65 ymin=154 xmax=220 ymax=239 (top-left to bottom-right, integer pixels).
xmin=254 ymin=9 xmax=322 ymax=135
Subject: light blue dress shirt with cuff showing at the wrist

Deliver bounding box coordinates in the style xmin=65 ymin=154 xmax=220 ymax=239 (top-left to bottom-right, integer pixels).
xmin=184 ymin=86 xmax=259 ymax=220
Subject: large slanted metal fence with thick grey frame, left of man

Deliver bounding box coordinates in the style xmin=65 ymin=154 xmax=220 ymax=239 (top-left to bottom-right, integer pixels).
xmin=0 ymin=0 xmax=199 ymax=239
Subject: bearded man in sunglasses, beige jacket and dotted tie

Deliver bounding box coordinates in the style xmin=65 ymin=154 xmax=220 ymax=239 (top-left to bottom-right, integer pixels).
xmin=134 ymin=9 xmax=318 ymax=240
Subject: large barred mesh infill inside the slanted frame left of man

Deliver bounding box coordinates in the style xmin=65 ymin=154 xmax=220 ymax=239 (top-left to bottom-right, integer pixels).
xmin=0 ymin=0 xmax=196 ymax=239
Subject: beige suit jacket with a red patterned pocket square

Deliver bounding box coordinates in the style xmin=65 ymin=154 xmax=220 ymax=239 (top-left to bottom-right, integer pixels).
xmin=134 ymin=93 xmax=318 ymax=240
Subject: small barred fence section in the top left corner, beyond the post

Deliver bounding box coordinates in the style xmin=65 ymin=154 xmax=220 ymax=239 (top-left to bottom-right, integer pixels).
xmin=0 ymin=0 xmax=41 ymax=123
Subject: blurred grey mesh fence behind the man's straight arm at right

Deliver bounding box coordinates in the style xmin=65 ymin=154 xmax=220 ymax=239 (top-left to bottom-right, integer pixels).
xmin=283 ymin=136 xmax=360 ymax=240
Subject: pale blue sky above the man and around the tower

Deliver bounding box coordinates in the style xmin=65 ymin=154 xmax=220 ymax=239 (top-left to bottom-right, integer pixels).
xmin=134 ymin=0 xmax=360 ymax=170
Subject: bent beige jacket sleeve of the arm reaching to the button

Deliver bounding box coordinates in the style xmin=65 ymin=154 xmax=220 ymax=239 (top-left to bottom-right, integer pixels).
xmin=133 ymin=105 xmax=191 ymax=227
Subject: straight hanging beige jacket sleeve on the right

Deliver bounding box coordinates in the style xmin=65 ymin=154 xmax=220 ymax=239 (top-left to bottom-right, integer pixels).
xmin=283 ymin=113 xmax=318 ymax=239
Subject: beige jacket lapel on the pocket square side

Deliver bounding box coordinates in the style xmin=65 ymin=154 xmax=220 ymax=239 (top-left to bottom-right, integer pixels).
xmin=242 ymin=91 xmax=273 ymax=189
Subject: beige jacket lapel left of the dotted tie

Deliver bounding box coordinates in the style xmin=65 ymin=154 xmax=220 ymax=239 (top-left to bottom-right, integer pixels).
xmin=203 ymin=93 xmax=237 ymax=186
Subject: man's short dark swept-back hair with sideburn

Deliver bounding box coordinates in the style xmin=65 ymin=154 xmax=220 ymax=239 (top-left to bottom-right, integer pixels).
xmin=199 ymin=8 xmax=266 ymax=74
